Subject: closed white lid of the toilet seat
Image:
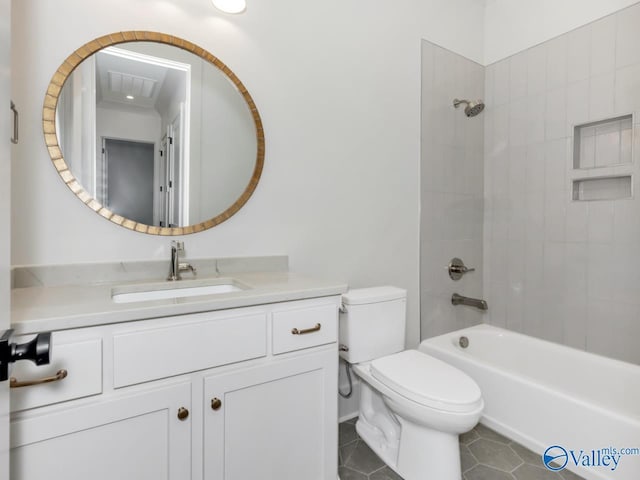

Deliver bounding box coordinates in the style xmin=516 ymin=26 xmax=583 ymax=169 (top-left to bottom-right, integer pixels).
xmin=371 ymin=350 xmax=482 ymax=412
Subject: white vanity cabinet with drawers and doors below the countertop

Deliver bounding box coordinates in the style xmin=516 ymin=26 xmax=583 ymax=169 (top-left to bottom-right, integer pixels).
xmin=11 ymin=296 xmax=340 ymax=480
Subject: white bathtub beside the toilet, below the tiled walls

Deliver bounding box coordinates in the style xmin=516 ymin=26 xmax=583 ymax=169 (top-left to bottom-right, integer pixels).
xmin=419 ymin=325 xmax=640 ymax=480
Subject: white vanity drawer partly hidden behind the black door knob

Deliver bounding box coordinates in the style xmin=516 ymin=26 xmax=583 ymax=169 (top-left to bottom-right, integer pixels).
xmin=11 ymin=332 xmax=102 ymax=412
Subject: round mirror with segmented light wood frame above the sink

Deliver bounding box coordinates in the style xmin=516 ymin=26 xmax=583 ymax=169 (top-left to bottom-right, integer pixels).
xmin=43 ymin=31 xmax=264 ymax=235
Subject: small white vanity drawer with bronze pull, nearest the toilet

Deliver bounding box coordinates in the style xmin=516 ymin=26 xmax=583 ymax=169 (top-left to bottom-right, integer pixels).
xmin=273 ymin=304 xmax=338 ymax=355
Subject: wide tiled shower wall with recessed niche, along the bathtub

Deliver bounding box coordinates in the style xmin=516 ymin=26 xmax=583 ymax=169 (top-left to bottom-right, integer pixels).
xmin=482 ymin=4 xmax=640 ymax=363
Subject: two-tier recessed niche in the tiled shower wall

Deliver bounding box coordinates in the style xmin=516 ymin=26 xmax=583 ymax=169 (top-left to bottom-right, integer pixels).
xmin=572 ymin=115 xmax=633 ymax=201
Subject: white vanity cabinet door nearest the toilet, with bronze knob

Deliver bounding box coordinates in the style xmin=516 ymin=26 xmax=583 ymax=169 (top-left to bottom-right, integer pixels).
xmin=204 ymin=345 xmax=338 ymax=480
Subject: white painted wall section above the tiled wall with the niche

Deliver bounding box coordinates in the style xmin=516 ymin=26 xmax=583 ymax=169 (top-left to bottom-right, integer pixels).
xmin=484 ymin=0 xmax=638 ymax=65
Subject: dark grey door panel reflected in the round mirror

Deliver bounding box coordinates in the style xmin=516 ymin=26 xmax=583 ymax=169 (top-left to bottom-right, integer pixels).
xmin=98 ymin=138 xmax=154 ymax=225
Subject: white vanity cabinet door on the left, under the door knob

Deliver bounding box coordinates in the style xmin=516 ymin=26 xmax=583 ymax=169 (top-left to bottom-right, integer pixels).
xmin=10 ymin=382 xmax=191 ymax=480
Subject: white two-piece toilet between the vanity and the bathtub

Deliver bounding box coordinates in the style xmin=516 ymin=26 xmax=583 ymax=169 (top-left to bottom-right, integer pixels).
xmin=340 ymin=287 xmax=484 ymax=480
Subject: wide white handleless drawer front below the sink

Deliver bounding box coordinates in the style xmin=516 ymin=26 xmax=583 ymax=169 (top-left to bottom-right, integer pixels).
xmin=113 ymin=312 xmax=267 ymax=388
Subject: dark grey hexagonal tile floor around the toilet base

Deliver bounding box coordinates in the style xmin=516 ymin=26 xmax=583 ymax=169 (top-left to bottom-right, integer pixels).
xmin=338 ymin=418 xmax=583 ymax=480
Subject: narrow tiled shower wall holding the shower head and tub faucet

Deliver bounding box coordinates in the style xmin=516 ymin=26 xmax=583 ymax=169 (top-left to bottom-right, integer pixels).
xmin=420 ymin=41 xmax=485 ymax=338
